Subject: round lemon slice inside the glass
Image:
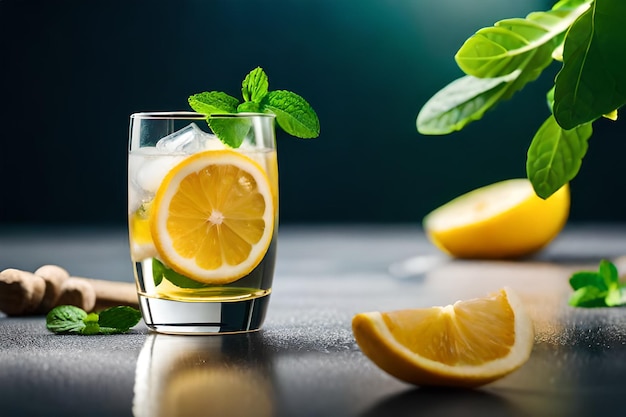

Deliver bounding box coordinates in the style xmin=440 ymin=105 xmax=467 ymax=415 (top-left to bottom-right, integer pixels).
xmin=150 ymin=150 xmax=275 ymax=284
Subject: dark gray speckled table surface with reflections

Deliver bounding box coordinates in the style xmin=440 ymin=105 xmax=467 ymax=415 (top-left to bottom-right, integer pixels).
xmin=0 ymin=225 xmax=626 ymax=417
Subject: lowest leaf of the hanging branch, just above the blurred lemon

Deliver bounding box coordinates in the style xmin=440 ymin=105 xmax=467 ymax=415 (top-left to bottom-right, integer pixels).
xmin=526 ymin=115 xmax=593 ymax=199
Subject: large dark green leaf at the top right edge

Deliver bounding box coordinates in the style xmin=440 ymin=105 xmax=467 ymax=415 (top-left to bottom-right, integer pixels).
xmin=554 ymin=0 xmax=626 ymax=129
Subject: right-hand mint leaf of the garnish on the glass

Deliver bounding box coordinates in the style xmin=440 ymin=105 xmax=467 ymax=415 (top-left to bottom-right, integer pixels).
xmin=261 ymin=90 xmax=320 ymax=139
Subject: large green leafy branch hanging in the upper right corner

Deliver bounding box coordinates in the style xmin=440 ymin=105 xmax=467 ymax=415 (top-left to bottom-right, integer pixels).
xmin=416 ymin=0 xmax=626 ymax=198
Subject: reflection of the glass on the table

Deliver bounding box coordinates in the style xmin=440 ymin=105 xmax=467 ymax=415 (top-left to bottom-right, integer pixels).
xmin=133 ymin=333 xmax=275 ymax=417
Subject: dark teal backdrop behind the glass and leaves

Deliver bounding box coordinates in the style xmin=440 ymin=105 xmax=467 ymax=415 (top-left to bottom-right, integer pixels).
xmin=0 ymin=0 xmax=626 ymax=225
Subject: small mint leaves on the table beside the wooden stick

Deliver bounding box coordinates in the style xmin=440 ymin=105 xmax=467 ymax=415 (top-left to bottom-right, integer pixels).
xmin=46 ymin=305 xmax=141 ymax=335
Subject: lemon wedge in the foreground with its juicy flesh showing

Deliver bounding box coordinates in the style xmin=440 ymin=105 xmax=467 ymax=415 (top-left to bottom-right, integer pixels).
xmin=352 ymin=288 xmax=534 ymax=387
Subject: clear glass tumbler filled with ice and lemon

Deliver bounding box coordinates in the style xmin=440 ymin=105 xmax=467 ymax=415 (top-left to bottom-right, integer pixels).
xmin=128 ymin=112 xmax=278 ymax=334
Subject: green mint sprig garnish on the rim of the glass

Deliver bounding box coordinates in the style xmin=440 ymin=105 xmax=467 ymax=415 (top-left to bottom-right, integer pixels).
xmin=188 ymin=67 xmax=320 ymax=148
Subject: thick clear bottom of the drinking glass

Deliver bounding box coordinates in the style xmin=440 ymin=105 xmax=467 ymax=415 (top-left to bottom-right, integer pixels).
xmin=139 ymin=294 xmax=270 ymax=334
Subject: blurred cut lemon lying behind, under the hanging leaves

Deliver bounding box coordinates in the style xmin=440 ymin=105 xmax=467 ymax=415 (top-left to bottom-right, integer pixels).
xmin=423 ymin=178 xmax=570 ymax=259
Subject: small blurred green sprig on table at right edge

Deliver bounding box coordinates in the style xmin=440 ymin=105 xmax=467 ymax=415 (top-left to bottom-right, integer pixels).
xmin=569 ymin=260 xmax=626 ymax=307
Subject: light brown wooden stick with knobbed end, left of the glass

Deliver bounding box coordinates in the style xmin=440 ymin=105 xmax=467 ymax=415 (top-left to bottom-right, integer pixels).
xmin=0 ymin=265 xmax=138 ymax=316
